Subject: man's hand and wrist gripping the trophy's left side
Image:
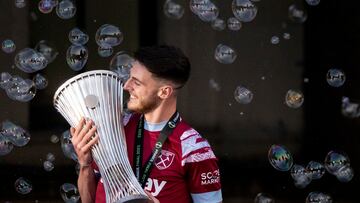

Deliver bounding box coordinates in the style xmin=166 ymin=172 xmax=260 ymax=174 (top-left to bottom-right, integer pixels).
xmin=70 ymin=118 xmax=99 ymax=166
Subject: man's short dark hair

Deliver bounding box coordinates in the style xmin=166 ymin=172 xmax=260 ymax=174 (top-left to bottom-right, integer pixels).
xmin=134 ymin=45 xmax=191 ymax=88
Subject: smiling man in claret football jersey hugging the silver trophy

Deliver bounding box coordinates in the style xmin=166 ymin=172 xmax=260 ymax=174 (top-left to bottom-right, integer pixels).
xmin=71 ymin=46 xmax=222 ymax=203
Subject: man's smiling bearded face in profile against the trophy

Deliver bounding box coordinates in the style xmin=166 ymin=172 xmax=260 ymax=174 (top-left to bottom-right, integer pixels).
xmin=124 ymin=61 xmax=161 ymax=113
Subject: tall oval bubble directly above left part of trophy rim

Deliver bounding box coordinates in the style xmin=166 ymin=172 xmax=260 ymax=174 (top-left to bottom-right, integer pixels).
xmin=66 ymin=45 xmax=88 ymax=71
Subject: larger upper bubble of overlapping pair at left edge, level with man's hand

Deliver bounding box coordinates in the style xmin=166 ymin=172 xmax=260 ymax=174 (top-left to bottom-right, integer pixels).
xmin=1 ymin=120 xmax=30 ymax=147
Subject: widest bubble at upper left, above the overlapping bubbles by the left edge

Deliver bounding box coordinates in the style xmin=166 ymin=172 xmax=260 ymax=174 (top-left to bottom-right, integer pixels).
xmin=15 ymin=48 xmax=48 ymax=73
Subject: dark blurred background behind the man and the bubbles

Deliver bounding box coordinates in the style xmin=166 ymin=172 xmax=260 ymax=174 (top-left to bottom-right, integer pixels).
xmin=0 ymin=0 xmax=360 ymax=203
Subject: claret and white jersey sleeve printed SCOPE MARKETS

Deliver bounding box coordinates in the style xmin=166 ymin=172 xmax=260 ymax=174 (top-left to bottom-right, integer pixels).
xmin=180 ymin=129 xmax=222 ymax=203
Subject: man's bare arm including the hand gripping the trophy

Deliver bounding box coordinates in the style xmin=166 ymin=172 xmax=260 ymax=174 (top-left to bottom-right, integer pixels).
xmin=70 ymin=118 xmax=99 ymax=203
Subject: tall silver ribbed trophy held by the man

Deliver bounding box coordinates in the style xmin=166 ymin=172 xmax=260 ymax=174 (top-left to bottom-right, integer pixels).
xmin=54 ymin=70 xmax=148 ymax=203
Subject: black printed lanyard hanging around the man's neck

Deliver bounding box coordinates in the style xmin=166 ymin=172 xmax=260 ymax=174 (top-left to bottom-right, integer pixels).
xmin=134 ymin=111 xmax=180 ymax=187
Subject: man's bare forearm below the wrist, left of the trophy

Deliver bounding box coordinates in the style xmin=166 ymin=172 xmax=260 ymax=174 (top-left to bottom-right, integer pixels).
xmin=78 ymin=166 xmax=96 ymax=203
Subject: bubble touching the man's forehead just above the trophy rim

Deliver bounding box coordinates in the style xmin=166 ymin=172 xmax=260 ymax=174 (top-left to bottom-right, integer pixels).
xmin=110 ymin=51 xmax=134 ymax=82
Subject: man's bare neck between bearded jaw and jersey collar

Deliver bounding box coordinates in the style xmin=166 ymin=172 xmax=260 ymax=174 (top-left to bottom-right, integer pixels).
xmin=144 ymin=97 xmax=176 ymax=123
